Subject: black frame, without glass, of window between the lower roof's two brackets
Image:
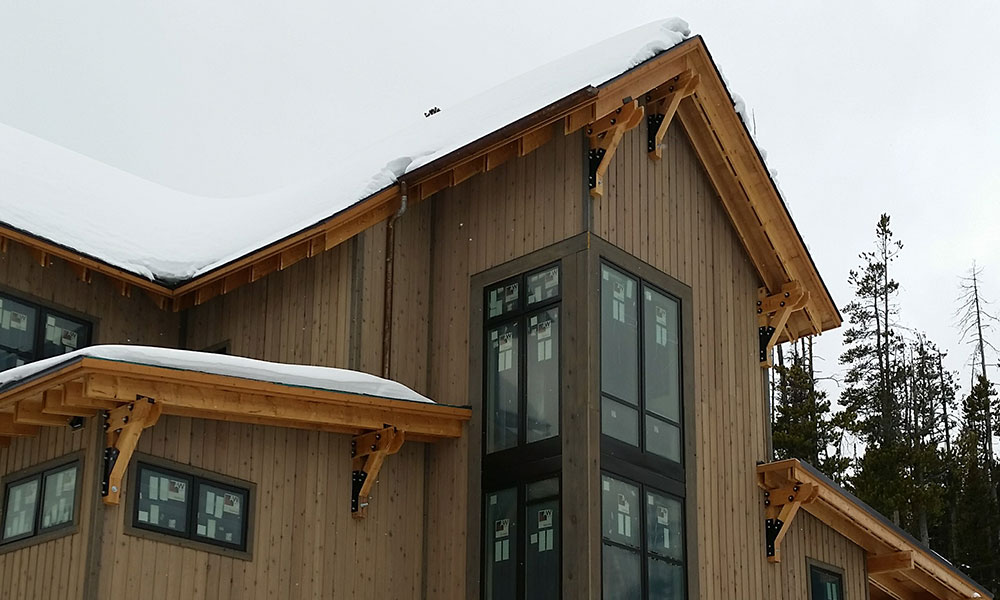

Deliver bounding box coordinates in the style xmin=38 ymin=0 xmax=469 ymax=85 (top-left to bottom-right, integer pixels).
xmin=125 ymin=453 xmax=257 ymax=560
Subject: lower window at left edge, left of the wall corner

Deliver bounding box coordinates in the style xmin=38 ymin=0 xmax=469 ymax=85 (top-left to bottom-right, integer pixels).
xmin=0 ymin=458 xmax=80 ymax=548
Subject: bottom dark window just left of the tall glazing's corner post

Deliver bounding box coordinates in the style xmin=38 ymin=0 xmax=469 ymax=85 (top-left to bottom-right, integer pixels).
xmin=483 ymin=477 xmax=562 ymax=600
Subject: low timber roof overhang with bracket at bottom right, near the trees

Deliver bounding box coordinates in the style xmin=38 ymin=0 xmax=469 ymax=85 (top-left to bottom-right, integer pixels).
xmin=757 ymin=459 xmax=993 ymax=600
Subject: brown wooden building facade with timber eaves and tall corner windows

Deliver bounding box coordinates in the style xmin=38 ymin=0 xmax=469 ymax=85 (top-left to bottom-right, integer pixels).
xmin=0 ymin=32 xmax=987 ymax=600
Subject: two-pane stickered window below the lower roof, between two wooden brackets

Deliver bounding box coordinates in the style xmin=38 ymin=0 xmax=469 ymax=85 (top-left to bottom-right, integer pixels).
xmin=131 ymin=461 xmax=252 ymax=552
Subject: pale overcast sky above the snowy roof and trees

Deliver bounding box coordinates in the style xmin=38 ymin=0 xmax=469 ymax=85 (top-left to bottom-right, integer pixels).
xmin=0 ymin=0 xmax=1000 ymax=400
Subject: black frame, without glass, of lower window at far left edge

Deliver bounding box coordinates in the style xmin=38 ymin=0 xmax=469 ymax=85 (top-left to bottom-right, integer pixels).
xmin=0 ymin=451 xmax=84 ymax=554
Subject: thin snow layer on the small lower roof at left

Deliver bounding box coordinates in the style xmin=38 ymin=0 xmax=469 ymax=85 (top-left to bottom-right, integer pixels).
xmin=0 ymin=345 xmax=433 ymax=404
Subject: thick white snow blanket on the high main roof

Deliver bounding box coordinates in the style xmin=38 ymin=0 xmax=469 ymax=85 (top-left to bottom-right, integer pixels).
xmin=0 ymin=19 xmax=690 ymax=282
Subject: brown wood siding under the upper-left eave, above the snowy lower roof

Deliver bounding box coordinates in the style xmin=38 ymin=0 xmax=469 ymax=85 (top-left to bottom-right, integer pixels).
xmin=0 ymin=243 xmax=180 ymax=347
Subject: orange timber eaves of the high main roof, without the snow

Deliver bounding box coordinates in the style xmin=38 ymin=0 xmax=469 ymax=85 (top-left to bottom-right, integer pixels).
xmin=0 ymin=36 xmax=841 ymax=340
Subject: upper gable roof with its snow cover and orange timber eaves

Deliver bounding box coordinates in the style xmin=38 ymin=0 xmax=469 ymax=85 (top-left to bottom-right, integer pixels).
xmin=0 ymin=19 xmax=841 ymax=337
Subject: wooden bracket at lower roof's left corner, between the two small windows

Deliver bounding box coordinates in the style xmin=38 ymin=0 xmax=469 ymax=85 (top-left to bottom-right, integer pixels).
xmin=101 ymin=397 xmax=163 ymax=505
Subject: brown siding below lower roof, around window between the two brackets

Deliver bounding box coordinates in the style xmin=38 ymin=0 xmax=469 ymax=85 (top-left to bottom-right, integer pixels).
xmin=88 ymin=417 xmax=424 ymax=600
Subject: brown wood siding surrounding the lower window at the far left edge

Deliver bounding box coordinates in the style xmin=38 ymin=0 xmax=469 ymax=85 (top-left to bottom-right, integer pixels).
xmin=0 ymin=422 xmax=97 ymax=600
